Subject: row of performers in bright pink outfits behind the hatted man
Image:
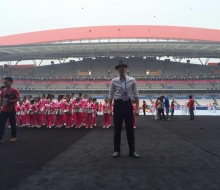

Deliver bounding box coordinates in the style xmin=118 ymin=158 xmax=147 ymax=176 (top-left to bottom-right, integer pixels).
xmin=13 ymin=95 xmax=136 ymax=128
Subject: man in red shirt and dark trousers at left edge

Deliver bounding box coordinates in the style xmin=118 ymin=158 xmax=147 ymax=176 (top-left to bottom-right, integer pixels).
xmin=0 ymin=77 xmax=20 ymax=142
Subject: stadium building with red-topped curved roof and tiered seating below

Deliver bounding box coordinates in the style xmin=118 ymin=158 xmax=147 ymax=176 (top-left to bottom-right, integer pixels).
xmin=0 ymin=25 xmax=220 ymax=106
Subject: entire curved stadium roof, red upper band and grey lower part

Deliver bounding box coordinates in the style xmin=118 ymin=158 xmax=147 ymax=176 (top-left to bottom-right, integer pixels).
xmin=0 ymin=26 xmax=220 ymax=61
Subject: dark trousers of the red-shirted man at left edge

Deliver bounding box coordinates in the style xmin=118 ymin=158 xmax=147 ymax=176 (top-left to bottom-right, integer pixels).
xmin=0 ymin=111 xmax=17 ymax=140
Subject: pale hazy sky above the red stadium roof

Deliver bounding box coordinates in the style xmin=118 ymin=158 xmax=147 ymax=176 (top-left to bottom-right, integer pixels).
xmin=0 ymin=0 xmax=220 ymax=64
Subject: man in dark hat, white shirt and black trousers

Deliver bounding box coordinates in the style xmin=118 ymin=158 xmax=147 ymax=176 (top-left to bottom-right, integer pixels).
xmin=108 ymin=61 xmax=139 ymax=158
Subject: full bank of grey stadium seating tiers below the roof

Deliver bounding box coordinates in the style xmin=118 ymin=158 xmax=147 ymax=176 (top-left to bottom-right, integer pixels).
xmin=0 ymin=57 xmax=220 ymax=104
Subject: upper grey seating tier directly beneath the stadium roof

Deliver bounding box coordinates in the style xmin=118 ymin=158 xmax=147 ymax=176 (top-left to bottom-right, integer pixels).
xmin=0 ymin=58 xmax=220 ymax=79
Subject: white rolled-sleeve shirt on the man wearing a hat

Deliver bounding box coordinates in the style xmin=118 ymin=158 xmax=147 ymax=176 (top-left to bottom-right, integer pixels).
xmin=108 ymin=75 xmax=139 ymax=100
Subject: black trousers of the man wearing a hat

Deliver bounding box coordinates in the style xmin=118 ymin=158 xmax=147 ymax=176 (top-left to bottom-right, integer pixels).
xmin=113 ymin=100 xmax=135 ymax=153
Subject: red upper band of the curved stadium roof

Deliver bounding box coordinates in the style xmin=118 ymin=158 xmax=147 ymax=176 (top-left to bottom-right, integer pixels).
xmin=0 ymin=25 xmax=220 ymax=46
